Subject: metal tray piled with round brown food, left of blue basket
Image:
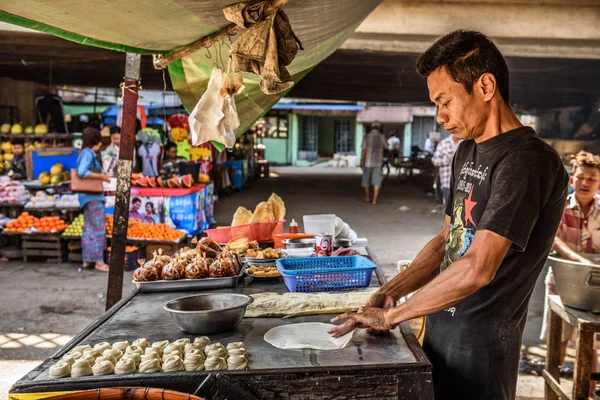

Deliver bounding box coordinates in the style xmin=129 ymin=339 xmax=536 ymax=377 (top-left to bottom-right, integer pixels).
xmin=133 ymin=237 xmax=244 ymax=292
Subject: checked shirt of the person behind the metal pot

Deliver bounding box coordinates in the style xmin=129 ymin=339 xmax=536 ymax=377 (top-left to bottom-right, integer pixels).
xmin=558 ymin=193 xmax=600 ymax=253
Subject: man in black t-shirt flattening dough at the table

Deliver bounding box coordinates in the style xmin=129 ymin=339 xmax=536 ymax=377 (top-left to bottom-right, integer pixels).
xmin=331 ymin=30 xmax=568 ymax=400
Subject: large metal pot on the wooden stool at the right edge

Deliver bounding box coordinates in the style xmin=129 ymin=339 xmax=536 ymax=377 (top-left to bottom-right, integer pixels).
xmin=548 ymin=254 xmax=600 ymax=312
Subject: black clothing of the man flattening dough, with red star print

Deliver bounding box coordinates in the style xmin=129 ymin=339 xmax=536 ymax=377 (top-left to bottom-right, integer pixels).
xmin=423 ymin=127 xmax=568 ymax=400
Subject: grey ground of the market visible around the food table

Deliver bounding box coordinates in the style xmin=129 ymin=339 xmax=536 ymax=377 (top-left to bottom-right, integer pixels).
xmin=0 ymin=168 xmax=560 ymax=400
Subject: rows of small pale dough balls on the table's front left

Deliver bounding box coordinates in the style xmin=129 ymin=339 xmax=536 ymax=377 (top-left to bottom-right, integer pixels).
xmin=48 ymin=336 xmax=248 ymax=379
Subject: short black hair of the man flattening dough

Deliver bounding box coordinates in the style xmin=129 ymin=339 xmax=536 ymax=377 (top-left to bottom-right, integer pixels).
xmin=415 ymin=29 xmax=509 ymax=104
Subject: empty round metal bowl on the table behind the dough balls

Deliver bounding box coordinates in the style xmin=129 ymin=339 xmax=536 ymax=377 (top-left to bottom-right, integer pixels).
xmin=163 ymin=293 xmax=254 ymax=335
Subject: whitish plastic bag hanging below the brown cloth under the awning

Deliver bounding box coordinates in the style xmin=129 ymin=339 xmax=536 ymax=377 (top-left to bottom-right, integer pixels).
xmin=188 ymin=68 xmax=225 ymax=146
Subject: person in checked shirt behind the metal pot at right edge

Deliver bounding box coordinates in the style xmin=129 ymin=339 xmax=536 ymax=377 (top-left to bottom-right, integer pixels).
xmin=541 ymin=151 xmax=600 ymax=387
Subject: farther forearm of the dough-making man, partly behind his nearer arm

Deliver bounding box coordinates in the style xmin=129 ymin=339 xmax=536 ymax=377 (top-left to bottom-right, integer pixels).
xmin=379 ymin=233 xmax=446 ymax=300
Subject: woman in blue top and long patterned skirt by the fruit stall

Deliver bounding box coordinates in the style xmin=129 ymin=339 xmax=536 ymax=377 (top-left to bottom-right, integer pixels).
xmin=77 ymin=126 xmax=110 ymax=272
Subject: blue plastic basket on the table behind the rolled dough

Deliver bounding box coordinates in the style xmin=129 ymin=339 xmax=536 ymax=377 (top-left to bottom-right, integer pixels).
xmin=277 ymin=256 xmax=377 ymax=292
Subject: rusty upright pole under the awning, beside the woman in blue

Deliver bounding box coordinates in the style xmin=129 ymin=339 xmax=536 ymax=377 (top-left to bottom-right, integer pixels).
xmin=106 ymin=53 xmax=141 ymax=310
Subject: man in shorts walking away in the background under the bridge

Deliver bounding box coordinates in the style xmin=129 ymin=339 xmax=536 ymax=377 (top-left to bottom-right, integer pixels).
xmin=360 ymin=121 xmax=387 ymax=204
